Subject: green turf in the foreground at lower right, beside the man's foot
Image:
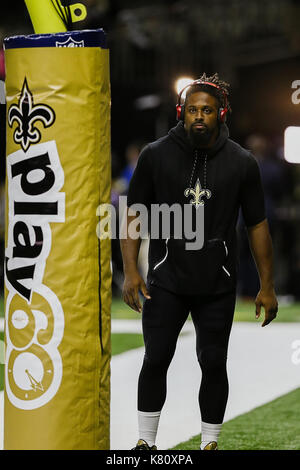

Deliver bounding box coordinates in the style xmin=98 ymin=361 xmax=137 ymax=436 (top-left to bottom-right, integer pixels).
xmin=174 ymin=388 xmax=300 ymax=450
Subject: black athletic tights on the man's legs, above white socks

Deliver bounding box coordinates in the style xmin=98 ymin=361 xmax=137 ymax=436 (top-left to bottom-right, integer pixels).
xmin=138 ymin=286 xmax=236 ymax=424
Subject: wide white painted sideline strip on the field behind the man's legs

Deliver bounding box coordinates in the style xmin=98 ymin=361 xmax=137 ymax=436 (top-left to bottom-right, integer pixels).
xmin=111 ymin=321 xmax=300 ymax=450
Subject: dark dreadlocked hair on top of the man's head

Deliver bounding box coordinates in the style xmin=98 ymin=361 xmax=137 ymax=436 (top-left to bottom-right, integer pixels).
xmin=185 ymin=72 xmax=231 ymax=112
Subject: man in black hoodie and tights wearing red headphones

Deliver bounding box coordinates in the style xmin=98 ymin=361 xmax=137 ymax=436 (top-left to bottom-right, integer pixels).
xmin=121 ymin=74 xmax=278 ymax=450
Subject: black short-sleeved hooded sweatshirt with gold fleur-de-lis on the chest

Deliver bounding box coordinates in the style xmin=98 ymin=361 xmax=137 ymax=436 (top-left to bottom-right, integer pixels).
xmin=127 ymin=122 xmax=265 ymax=295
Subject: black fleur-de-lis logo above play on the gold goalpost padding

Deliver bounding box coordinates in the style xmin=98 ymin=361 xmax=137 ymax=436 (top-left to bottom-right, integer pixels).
xmin=8 ymin=78 xmax=55 ymax=152
